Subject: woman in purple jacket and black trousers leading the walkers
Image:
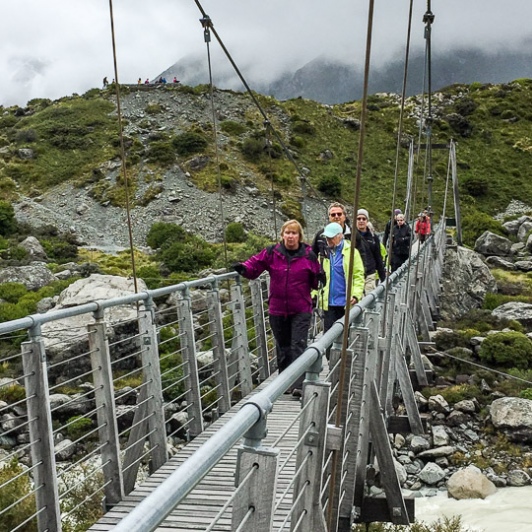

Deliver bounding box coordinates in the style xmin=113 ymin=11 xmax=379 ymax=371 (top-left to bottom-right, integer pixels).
xmin=233 ymin=220 xmax=325 ymax=397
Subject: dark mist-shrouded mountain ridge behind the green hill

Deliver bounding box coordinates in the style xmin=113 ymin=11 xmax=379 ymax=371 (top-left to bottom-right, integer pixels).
xmin=159 ymin=44 xmax=532 ymax=104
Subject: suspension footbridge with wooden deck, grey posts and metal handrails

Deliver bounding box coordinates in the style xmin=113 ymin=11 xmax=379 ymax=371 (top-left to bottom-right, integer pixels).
xmin=0 ymin=224 xmax=454 ymax=531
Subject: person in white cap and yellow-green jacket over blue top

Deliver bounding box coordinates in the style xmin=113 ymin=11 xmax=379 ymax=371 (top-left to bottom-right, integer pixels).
xmin=317 ymin=222 xmax=364 ymax=332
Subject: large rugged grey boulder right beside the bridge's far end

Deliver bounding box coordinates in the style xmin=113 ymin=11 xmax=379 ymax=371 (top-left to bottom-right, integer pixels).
xmin=440 ymin=246 xmax=497 ymax=320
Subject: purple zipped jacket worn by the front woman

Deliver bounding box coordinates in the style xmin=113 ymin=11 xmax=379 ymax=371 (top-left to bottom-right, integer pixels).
xmin=242 ymin=242 xmax=321 ymax=316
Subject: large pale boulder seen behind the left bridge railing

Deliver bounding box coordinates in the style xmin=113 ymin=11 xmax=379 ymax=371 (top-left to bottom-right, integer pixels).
xmin=41 ymin=274 xmax=147 ymax=382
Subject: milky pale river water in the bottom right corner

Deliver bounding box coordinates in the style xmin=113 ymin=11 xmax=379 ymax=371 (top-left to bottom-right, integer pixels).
xmin=415 ymin=486 xmax=532 ymax=532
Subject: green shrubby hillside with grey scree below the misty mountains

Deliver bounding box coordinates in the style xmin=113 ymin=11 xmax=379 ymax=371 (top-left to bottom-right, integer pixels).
xmin=0 ymin=80 xmax=532 ymax=247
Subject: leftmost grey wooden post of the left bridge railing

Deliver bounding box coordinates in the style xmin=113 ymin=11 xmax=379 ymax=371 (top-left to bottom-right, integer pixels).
xmin=22 ymin=326 xmax=61 ymax=532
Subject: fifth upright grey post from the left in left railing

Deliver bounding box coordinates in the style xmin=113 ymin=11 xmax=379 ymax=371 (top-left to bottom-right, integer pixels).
xmin=207 ymin=286 xmax=231 ymax=414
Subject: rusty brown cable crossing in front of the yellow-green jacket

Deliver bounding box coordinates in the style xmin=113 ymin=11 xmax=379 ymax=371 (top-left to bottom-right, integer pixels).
xmin=327 ymin=0 xmax=375 ymax=530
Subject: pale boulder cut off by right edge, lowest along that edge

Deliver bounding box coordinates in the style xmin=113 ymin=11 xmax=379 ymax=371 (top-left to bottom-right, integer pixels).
xmin=490 ymin=397 xmax=532 ymax=443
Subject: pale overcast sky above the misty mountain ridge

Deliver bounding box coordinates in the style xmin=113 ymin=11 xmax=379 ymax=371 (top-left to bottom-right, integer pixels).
xmin=0 ymin=0 xmax=532 ymax=106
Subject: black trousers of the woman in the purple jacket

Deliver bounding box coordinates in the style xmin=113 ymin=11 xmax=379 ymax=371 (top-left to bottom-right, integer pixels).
xmin=270 ymin=312 xmax=311 ymax=389
